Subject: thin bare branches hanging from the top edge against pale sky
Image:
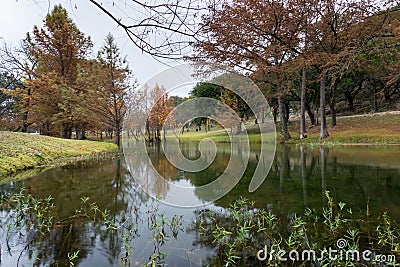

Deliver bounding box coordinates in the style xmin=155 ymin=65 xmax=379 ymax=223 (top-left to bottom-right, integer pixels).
xmin=89 ymin=0 xmax=212 ymax=60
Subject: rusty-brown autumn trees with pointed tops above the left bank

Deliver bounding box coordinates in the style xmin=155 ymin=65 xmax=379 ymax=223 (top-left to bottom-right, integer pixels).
xmin=0 ymin=5 xmax=136 ymax=145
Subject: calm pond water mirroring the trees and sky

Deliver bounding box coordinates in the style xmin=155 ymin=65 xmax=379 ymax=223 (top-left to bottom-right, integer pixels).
xmin=0 ymin=143 xmax=400 ymax=266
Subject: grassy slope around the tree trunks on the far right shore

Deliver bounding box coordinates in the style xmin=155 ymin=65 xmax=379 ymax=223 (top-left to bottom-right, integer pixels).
xmin=172 ymin=112 xmax=400 ymax=145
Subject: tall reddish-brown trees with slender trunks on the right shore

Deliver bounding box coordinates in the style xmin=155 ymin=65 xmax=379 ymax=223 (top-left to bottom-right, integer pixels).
xmin=187 ymin=0 xmax=400 ymax=140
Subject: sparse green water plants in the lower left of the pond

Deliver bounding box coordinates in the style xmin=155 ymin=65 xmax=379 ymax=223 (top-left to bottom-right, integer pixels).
xmin=0 ymin=189 xmax=184 ymax=266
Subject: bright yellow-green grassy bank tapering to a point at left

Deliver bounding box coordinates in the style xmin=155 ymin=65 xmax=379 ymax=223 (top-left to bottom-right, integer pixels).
xmin=0 ymin=131 xmax=117 ymax=178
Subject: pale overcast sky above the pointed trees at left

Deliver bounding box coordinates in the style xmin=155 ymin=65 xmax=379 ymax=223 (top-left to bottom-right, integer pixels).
xmin=0 ymin=0 xmax=194 ymax=95
